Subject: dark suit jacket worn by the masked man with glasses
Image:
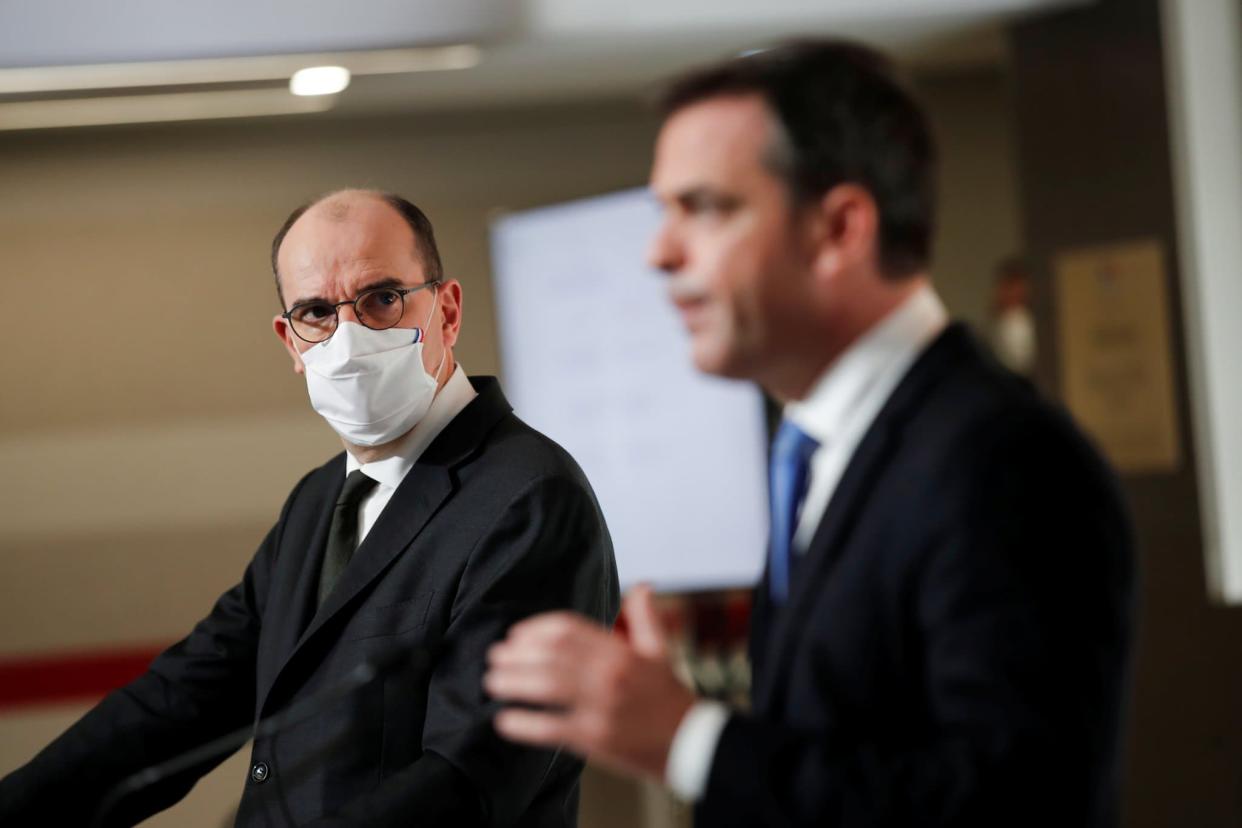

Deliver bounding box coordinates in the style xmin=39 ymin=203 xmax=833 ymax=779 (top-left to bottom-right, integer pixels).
xmin=0 ymin=377 xmax=617 ymax=827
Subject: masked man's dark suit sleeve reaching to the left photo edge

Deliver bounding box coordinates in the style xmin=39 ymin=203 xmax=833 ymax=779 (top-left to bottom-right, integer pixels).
xmin=0 ymin=471 xmax=309 ymax=826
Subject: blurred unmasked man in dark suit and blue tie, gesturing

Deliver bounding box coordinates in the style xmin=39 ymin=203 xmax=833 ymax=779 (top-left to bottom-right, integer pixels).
xmin=484 ymin=42 xmax=1134 ymax=827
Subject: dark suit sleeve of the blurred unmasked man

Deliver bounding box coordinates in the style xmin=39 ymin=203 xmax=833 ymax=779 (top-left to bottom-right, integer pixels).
xmin=697 ymin=412 xmax=1133 ymax=828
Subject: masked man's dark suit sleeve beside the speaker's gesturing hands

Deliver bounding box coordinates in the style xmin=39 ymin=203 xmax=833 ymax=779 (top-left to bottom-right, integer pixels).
xmin=315 ymin=474 xmax=619 ymax=826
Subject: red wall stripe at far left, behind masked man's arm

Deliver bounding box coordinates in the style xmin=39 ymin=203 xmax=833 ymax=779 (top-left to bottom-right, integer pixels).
xmin=0 ymin=644 xmax=164 ymax=710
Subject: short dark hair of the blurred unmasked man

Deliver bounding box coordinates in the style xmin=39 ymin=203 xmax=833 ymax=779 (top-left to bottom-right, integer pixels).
xmin=658 ymin=40 xmax=935 ymax=278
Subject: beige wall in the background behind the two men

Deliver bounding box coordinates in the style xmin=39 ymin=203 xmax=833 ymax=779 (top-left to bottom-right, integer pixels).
xmin=0 ymin=72 xmax=1017 ymax=827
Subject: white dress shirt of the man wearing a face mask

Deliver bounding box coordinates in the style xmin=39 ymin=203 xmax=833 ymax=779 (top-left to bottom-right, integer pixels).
xmin=345 ymin=362 xmax=478 ymax=544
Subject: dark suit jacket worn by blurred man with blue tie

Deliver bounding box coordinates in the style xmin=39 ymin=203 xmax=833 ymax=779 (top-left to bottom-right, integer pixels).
xmin=697 ymin=325 xmax=1134 ymax=828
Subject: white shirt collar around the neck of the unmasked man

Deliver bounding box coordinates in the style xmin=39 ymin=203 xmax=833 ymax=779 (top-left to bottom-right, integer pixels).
xmin=785 ymin=284 xmax=949 ymax=444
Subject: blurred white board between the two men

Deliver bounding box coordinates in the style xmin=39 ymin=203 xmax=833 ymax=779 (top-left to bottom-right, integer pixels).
xmin=492 ymin=190 xmax=768 ymax=591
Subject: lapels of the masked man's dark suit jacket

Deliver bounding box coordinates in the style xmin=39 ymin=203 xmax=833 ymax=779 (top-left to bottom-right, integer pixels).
xmin=258 ymin=377 xmax=512 ymax=711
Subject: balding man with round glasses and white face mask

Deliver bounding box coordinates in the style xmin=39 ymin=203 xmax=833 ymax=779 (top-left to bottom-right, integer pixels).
xmin=0 ymin=191 xmax=617 ymax=826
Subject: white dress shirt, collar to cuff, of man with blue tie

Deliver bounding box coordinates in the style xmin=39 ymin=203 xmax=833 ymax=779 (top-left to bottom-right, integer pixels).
xmin=664 ymin=287 xmax=949 ymax=802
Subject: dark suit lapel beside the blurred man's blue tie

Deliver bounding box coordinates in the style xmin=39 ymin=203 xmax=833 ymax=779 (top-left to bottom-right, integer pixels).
xmin=754 ymin=324 xmax=970 ymax=711
